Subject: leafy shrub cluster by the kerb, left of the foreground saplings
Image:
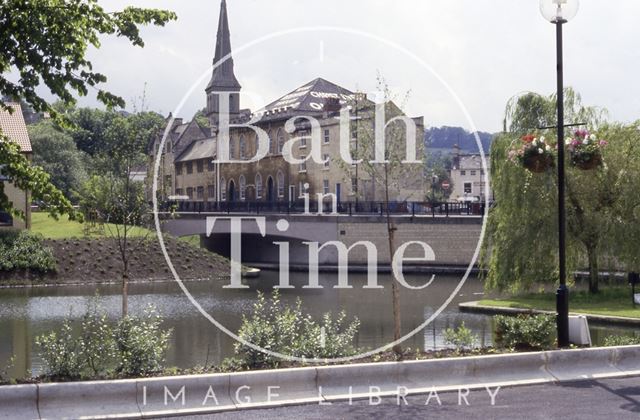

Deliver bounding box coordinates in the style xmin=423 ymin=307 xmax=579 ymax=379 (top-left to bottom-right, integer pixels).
xmin=36 ymin=297 xmax=171 ymax=379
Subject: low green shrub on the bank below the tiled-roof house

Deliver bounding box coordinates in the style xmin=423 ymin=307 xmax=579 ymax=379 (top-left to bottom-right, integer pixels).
xmin=0 ymin=230 xmax=56 ymax=274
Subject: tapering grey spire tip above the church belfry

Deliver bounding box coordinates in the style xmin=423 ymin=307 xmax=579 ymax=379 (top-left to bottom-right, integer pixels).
xmin=207 ymin=0 xmax=240 ymax=91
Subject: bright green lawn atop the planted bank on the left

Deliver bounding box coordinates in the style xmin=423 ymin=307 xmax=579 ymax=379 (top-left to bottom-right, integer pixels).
xmin=31 ymin=212 xmax=152 ymax=239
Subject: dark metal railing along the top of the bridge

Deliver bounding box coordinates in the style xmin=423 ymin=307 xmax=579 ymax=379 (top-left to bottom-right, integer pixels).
xmin=161 ymin=200 xmax=485 ymax=217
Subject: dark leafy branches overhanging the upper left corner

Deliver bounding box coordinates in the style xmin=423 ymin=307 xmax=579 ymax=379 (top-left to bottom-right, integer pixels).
xmin=0 ymin=0 xmax=176 ymax=217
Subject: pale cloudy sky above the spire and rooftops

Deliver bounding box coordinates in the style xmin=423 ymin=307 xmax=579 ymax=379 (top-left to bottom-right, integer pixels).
xmin=31 ymin=0 xmax=640 ymax=132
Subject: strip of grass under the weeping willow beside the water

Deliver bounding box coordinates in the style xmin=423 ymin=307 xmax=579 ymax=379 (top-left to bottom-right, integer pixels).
xmin=479 ymin=286 xmax=640 ymax=318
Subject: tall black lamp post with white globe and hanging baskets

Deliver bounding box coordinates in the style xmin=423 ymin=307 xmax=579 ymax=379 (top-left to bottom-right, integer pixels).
xmin=540 ymin=0 xmax=580 ymax=347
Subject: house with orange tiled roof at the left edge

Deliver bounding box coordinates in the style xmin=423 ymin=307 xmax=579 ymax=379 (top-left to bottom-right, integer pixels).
xmin=0 ymin=102 xmax=32 ymax=229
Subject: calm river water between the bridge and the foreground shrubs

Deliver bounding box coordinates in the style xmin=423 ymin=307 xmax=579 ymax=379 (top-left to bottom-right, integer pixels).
xmin=0 ymin=272 xmax=636 ymax=377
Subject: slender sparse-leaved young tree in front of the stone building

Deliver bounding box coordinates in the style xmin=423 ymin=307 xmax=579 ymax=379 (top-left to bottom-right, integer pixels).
xmin=345 ymin=77 xmax=424 ymax=355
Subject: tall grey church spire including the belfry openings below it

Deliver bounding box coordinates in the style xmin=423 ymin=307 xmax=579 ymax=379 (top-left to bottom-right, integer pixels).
xmin=205 ymin=0 xmax=241 ymax=126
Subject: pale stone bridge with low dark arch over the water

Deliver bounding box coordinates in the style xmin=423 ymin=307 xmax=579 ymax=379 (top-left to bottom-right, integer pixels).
xmin=163 ymin=213 xmax=483 ymax=268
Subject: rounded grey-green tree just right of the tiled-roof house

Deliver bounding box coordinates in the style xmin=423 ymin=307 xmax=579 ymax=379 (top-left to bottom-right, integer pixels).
xmin=29 ymin=120 xmax=87 ymax=199
